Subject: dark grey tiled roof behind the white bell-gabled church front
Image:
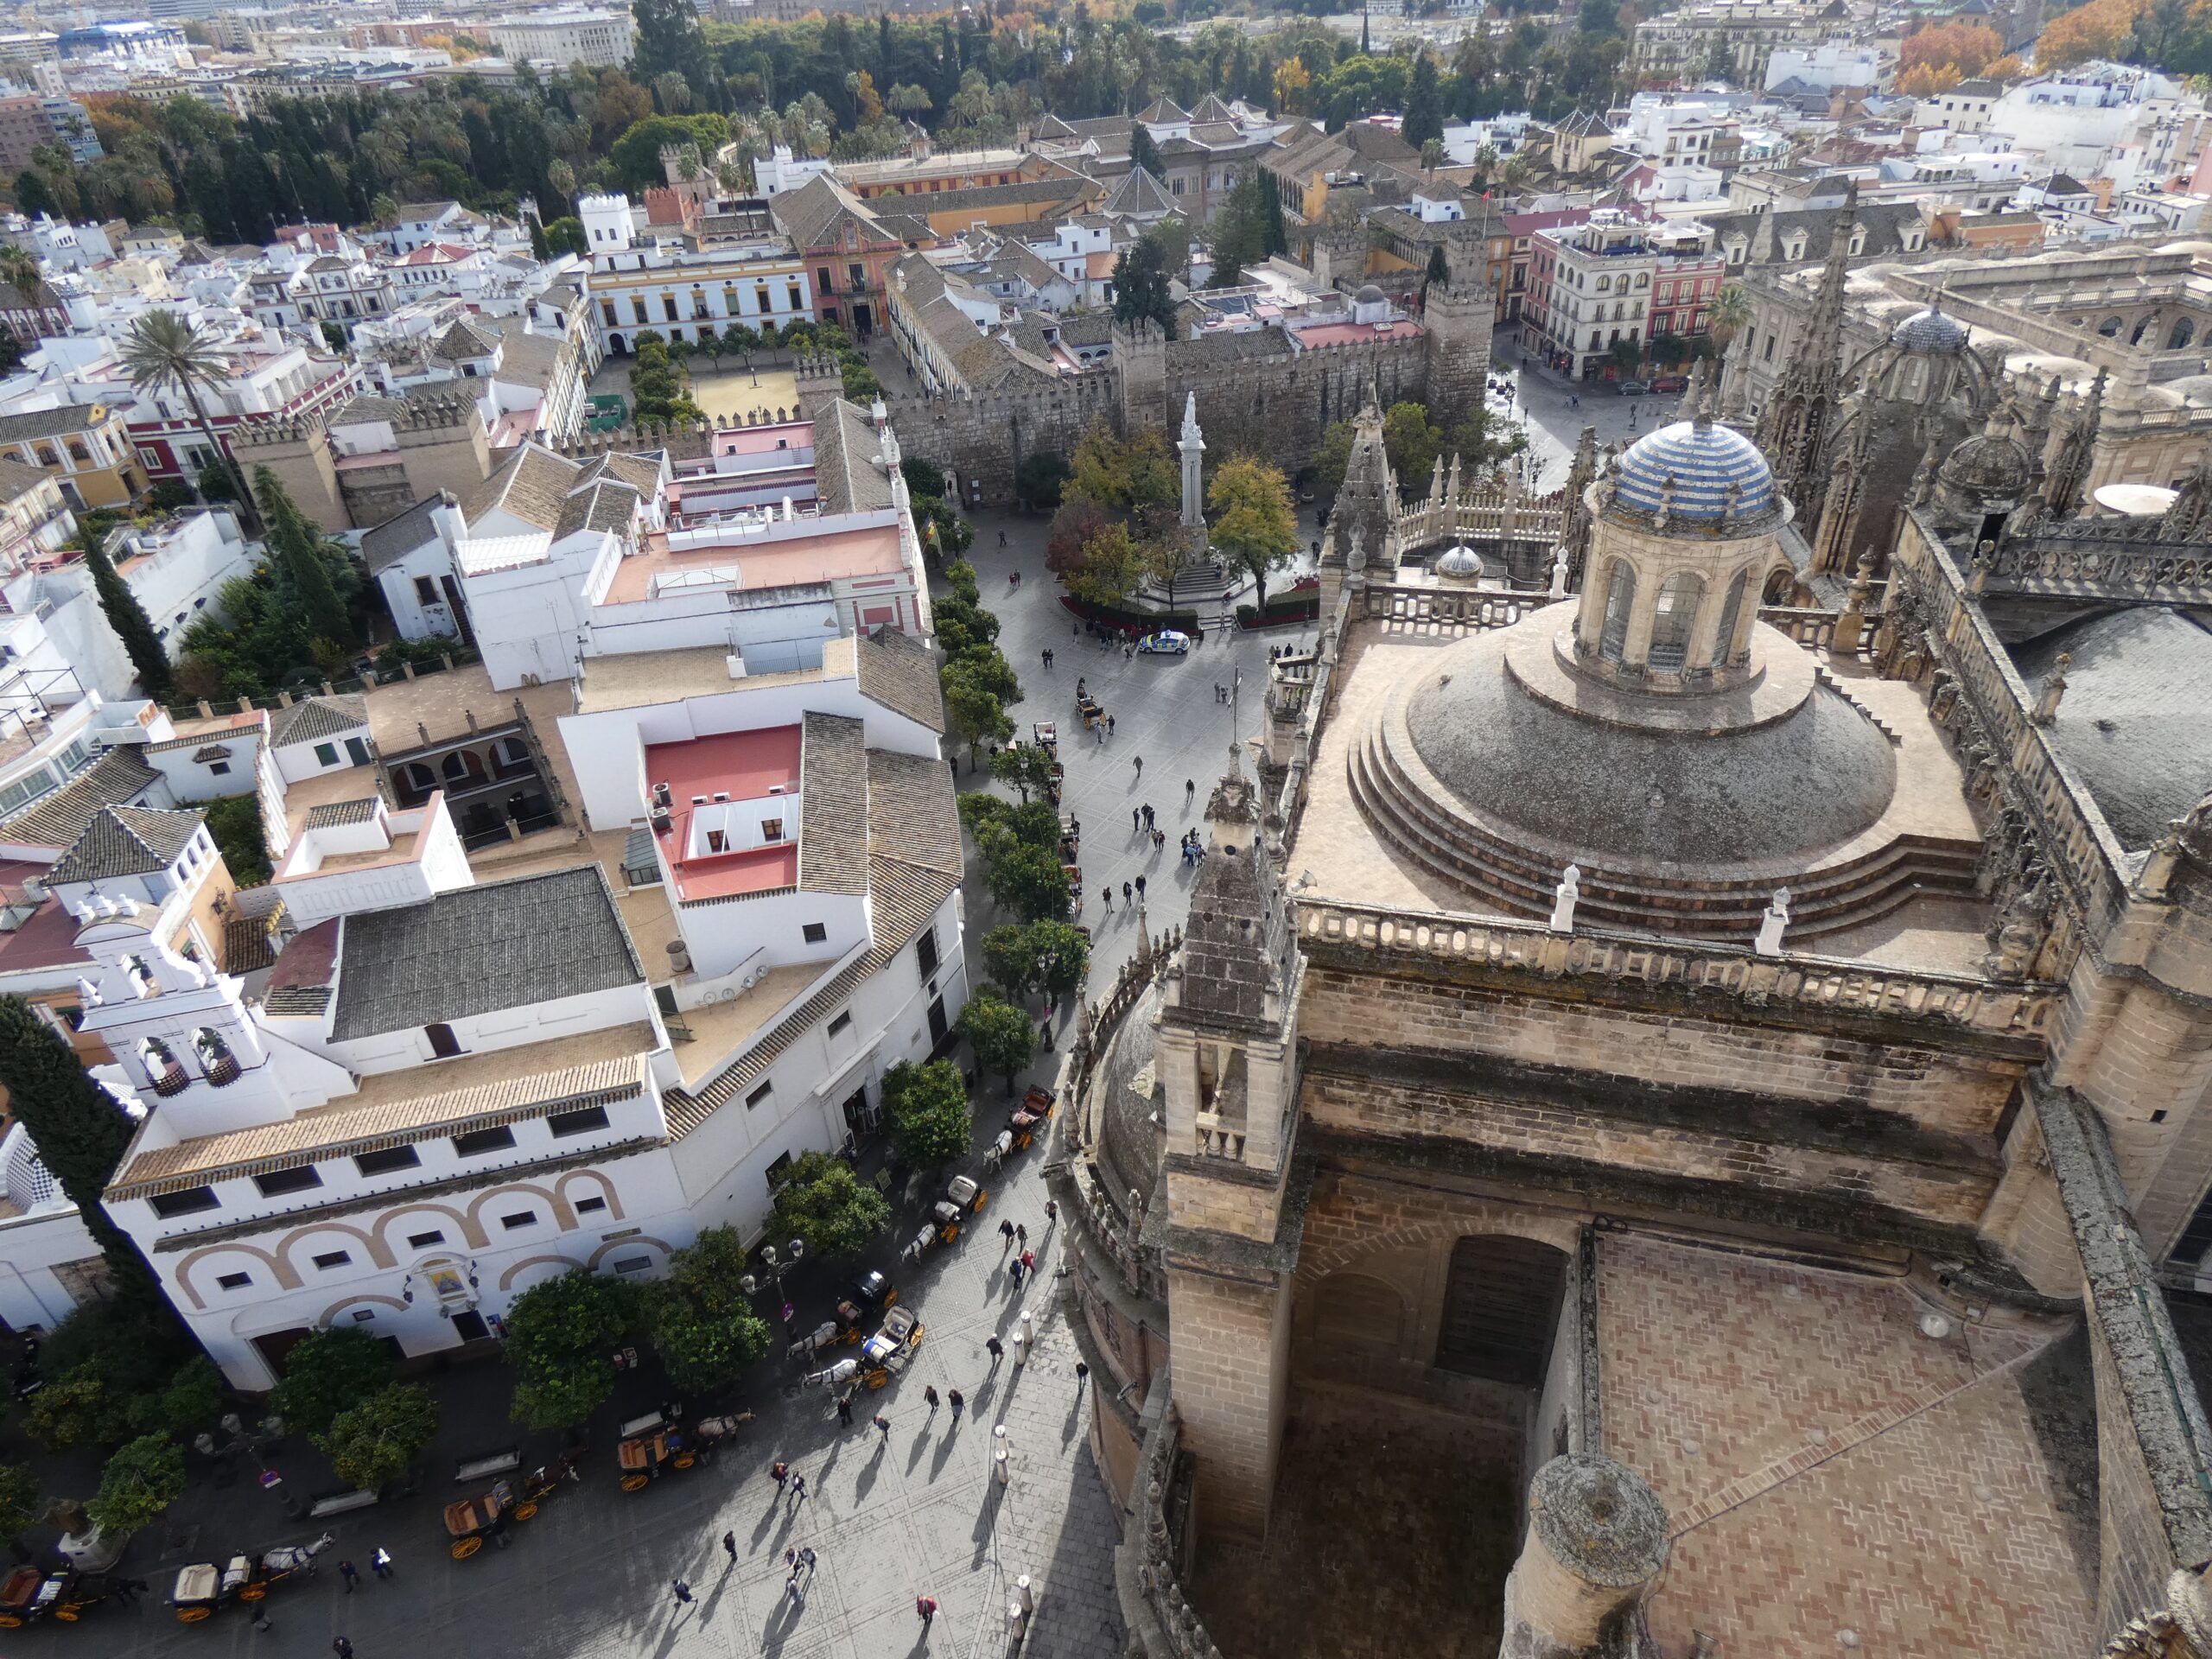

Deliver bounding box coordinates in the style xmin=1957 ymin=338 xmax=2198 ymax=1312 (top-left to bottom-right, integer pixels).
xmin=332 ymin=865 xmax=646 ymax=1042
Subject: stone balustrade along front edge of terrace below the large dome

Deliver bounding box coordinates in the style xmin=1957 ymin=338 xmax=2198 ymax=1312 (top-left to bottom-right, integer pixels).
xmin=1296 ymin=902 xmax=2063 ymax=1035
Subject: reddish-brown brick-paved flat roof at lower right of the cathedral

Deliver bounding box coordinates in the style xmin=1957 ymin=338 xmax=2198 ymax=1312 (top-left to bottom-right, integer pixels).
xmin=1597 ymin=1234 xmax=2094 ymax=1659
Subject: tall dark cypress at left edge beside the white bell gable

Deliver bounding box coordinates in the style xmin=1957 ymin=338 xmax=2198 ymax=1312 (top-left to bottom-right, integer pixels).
xmin=0 ymin=998 xmax=159 ymax=1305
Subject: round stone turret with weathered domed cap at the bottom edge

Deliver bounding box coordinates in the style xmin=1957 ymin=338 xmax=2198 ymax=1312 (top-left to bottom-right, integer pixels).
xmin=1495 ymin=1459 xmax=1666 ymax=1659
